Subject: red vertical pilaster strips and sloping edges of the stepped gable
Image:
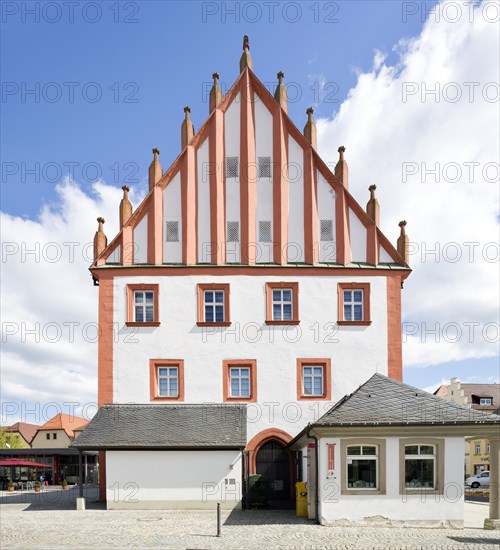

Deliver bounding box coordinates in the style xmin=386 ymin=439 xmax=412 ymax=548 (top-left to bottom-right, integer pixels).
xmin=94 ymin=67 xmax=408 ymax=267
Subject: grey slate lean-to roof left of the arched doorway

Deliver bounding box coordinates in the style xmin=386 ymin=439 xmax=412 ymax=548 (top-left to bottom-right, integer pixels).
xmin=71 ymin=404 xmax=247 ymax=450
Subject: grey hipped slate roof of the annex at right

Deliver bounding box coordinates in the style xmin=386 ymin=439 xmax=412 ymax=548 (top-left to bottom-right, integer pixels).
xmin=313 ymin=374 xmax=500 ymax=429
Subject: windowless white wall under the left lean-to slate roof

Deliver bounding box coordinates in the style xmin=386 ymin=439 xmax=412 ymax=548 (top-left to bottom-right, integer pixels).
xmin=106 ymin=450 xmax=241 ymax=510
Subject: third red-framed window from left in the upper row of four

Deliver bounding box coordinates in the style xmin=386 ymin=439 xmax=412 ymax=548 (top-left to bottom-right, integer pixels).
xmin=266 ymin=282 xmax=300 ymax=325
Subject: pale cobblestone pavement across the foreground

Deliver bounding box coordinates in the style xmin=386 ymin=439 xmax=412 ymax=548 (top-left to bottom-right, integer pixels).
xmin=0 ymin=489 xmax=500 ymax=550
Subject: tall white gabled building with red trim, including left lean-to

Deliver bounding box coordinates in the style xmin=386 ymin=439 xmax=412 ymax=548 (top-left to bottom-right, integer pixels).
xmin=73 ymin=36 xmax=496 ymax=519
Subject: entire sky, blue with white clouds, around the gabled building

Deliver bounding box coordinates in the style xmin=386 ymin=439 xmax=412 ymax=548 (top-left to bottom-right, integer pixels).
xmin=0 ymin=0 xmax=500 ymax=421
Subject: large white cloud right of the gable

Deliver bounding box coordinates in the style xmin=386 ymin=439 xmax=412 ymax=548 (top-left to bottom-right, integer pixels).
xmin=317 ymin=1 xmax=500 ymax=366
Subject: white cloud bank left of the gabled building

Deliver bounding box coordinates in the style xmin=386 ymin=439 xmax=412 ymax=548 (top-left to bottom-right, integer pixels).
xmin=0 ymin=179 xmax=142 ymax=423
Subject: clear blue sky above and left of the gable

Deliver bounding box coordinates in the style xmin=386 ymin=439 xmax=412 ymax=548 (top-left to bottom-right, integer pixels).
xmin=1 ymin=1 xmax=432 ymax=217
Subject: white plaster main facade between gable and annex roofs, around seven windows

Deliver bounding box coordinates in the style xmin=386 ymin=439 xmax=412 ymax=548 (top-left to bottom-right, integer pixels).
xmin=113 ymin=275 xmax=387 ymax=440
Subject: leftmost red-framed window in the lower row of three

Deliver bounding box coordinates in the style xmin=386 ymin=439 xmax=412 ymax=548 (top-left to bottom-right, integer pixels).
xmin=149 ymin=359 xmax=184 ymax=401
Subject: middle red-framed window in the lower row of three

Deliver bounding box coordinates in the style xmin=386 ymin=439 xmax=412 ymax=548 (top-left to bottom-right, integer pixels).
xmin=222 ymin=359 xmax=257 ymax=403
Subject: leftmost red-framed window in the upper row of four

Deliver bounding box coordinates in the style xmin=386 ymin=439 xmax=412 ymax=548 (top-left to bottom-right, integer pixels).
xmin=125 ymin=284 xmax=160 ymax=327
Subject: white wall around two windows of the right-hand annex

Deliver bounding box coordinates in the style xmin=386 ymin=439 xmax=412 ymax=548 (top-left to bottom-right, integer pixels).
xmin=319 ymin=435 xmax=464 ymax=527
